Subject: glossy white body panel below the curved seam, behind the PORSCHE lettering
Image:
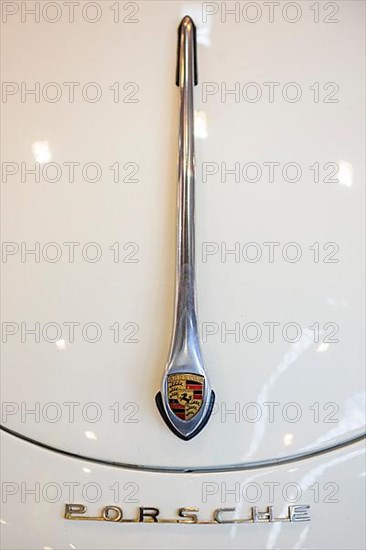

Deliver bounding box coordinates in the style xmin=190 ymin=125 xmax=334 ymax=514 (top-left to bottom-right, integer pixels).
xmin=1 ymin=434 xmax=365 ymax=550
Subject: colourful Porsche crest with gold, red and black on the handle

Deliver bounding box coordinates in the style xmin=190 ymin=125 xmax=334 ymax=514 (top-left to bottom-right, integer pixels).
xmin=168 ymin=374 xmax=205 ymax=420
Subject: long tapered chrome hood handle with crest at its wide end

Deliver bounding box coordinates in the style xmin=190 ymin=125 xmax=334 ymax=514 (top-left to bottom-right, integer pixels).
xmin=156 ymin=16 xmax=215 ymax=440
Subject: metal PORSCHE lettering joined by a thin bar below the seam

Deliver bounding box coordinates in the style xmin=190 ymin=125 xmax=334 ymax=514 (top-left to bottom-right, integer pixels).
xmin=64 ymin=504 xmax=311 ymax=525
